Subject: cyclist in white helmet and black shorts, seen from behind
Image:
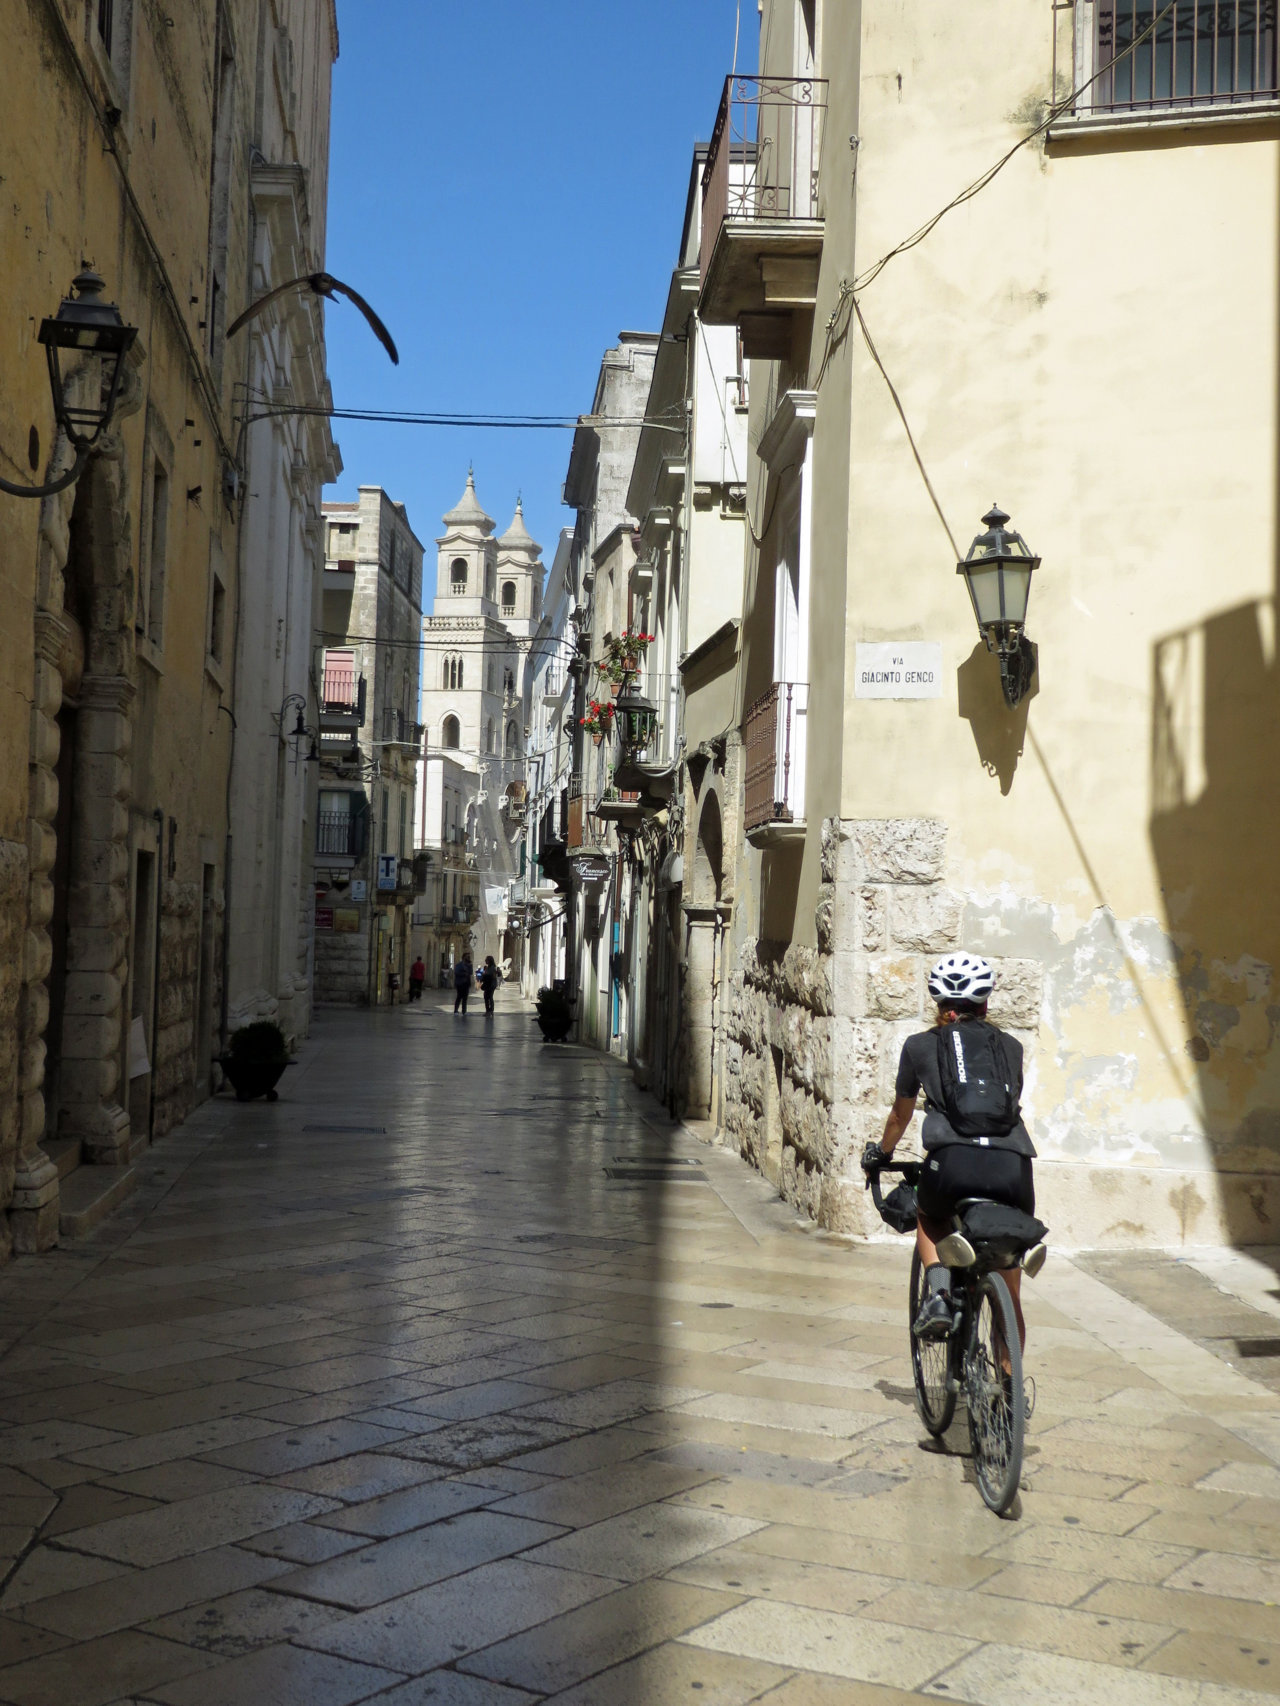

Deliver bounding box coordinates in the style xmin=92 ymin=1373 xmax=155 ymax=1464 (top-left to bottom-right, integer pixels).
xmin=862 ymin=954 xmax=1036 ymax=1344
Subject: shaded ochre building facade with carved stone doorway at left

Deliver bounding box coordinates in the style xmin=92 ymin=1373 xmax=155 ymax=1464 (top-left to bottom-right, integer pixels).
xmin=0 ymin=0 xmax=338 ymax=1252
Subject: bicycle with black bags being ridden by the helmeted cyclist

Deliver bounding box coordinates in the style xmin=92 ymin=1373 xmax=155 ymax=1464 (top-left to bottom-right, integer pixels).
xmin=867 ymin=1162 xmax=1048 ymax=1517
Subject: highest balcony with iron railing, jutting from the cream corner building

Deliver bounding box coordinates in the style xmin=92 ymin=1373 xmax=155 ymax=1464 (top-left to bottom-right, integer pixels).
xmin=698 ymin=77 xmax=826 ymax=360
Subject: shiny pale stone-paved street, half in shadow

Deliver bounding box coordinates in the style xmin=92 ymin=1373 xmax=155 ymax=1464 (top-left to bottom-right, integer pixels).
xmin=0 ymin=996 xmax=1280 ymax=1706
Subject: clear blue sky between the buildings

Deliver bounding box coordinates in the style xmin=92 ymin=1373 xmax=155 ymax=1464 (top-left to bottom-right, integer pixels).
xmin=324 ymin=0 xmax=758 ymax=595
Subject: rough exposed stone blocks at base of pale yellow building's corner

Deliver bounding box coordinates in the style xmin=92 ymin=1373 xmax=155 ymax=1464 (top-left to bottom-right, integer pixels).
xmin=724 ymin=819 xmax=1043 ymax=1233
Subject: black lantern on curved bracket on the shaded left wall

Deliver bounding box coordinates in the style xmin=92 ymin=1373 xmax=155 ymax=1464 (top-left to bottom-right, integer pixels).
xmin=0 ymin=266 xmax=138 ymax=498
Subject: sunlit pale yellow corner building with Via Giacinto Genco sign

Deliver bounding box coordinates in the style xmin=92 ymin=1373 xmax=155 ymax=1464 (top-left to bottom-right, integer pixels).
xmin=686 ymin=0 xmax=1280 ymax=1245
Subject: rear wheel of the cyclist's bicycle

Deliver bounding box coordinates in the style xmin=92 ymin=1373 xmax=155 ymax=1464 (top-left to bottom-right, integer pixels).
xmin=964 ymin=1273 xmax=1026 ymax=1517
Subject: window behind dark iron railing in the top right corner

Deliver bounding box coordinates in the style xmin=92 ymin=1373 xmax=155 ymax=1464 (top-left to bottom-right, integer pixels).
xmin=1094 ymin=0 xmax=1277 ymax=111
